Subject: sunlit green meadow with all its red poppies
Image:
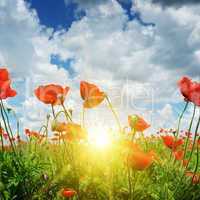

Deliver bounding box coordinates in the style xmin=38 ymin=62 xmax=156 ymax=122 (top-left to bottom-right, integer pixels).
xmin=0 ymin=68 xmax=200 ymax=200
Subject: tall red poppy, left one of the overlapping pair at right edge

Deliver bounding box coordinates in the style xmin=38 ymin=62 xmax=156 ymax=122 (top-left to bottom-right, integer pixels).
xmin=178 ymin=76 xmax=192 ymax=101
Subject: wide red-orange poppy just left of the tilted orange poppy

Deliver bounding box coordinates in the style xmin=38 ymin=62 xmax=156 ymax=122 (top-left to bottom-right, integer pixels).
xmin=35 ymin=84 xmax=69 ymax=105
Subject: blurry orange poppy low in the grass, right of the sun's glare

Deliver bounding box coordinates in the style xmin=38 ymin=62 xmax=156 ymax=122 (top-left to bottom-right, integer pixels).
xmin=128 ymin=151 xmax=154 ymax=170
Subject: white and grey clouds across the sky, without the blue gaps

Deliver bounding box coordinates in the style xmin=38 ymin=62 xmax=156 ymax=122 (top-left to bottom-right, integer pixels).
xmin=0 ymin=0 xmax=200 ymax=132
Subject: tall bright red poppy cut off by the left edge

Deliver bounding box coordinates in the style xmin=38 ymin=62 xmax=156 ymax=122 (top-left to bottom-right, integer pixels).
xmin=0 ymin=68 xmax=17 ymax=99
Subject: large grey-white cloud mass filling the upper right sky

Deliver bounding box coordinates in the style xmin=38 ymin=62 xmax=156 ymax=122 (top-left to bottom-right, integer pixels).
xmin=55 ymin=1 xmax=200 ymax=103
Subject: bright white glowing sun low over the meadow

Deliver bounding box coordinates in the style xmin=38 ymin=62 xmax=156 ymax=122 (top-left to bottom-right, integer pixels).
xmin=88 ymin=126 xmax=110 ymax=149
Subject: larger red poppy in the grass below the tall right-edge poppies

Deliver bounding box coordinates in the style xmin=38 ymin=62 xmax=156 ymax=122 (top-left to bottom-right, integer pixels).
xmin=162 ymin=135 xmax=184 ymax=150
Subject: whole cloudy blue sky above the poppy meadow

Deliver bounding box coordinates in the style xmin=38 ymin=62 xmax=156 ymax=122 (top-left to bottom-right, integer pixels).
xmin=0 ymin=0 xmax=200 ymax=131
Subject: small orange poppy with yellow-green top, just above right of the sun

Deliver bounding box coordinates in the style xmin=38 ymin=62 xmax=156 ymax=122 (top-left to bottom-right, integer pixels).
xmin=128 ymin=115 xmax=150 ymax=132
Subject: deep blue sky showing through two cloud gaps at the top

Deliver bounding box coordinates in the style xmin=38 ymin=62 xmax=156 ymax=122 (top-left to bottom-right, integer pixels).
xmin=26 ymin=0 xmax=155 ymax=30
